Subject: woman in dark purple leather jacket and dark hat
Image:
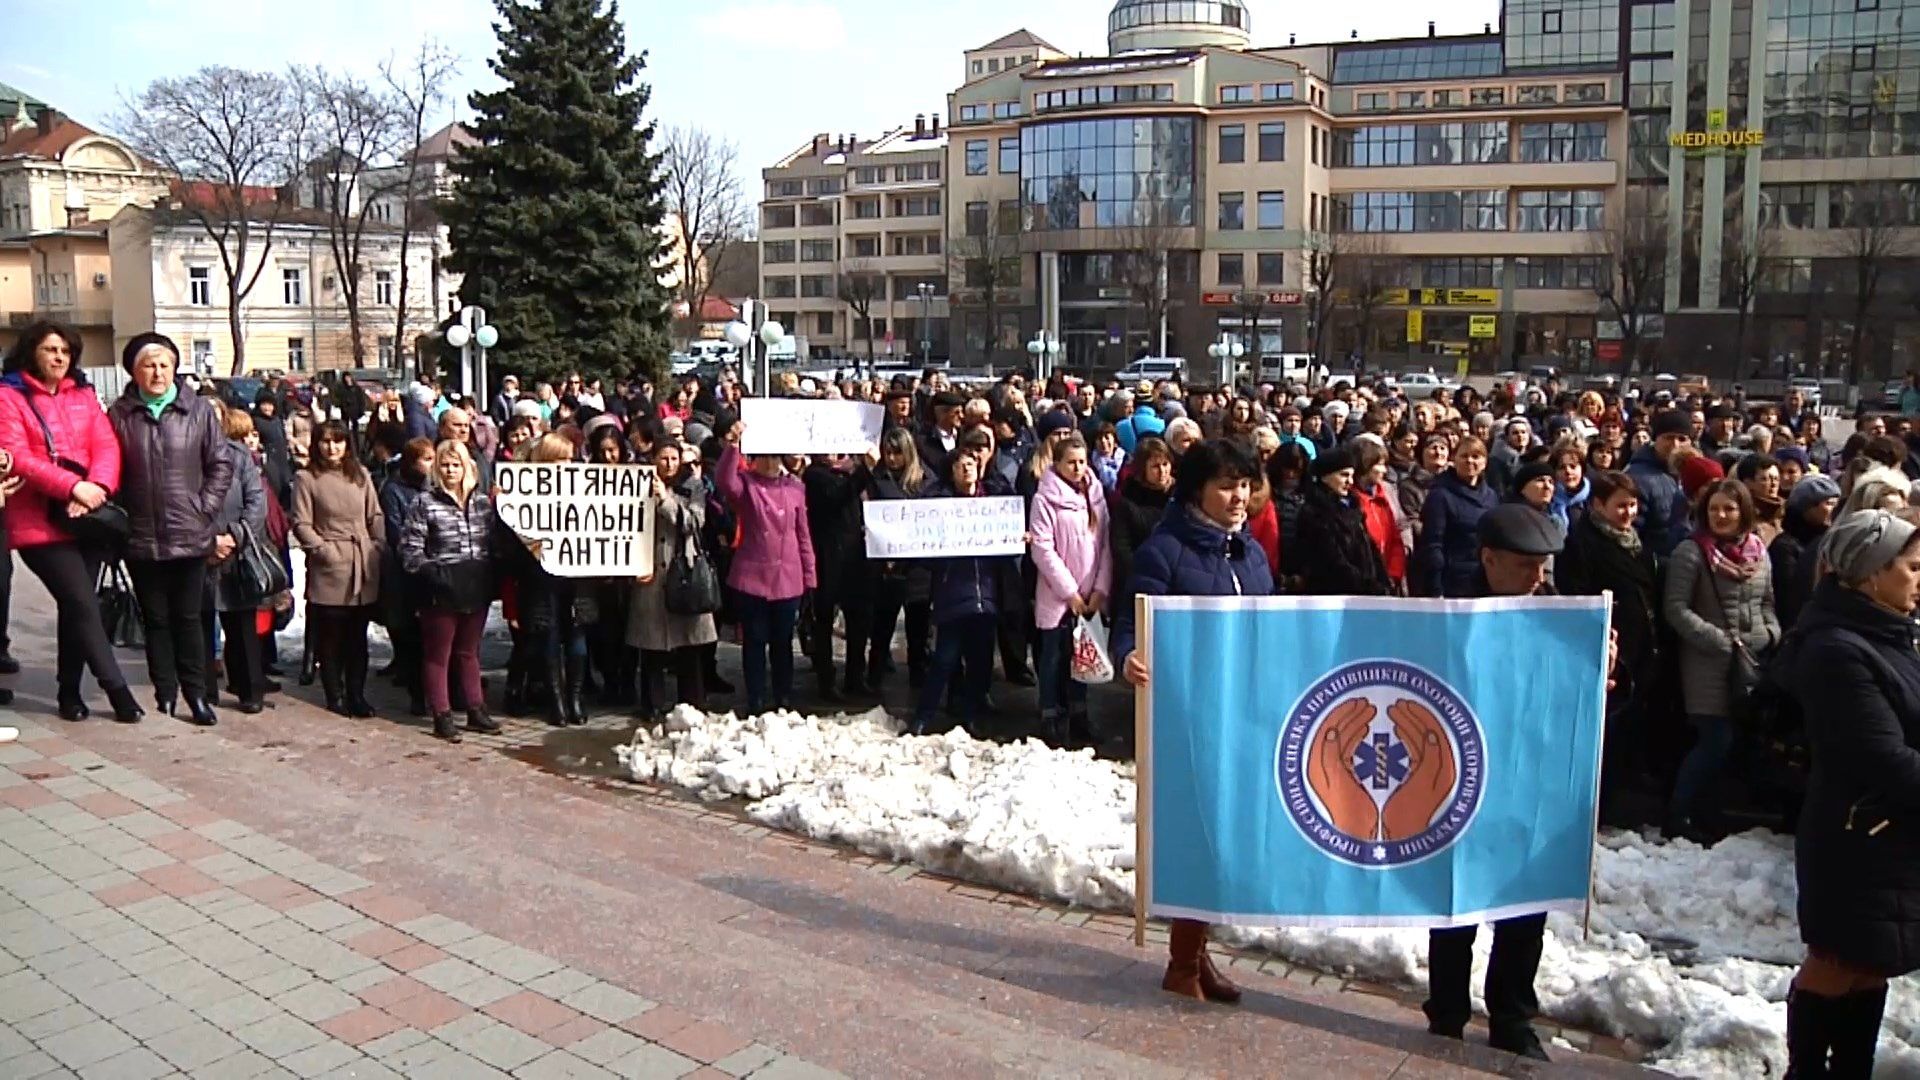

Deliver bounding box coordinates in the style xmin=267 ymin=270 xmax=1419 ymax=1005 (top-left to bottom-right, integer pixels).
xmin=108 ymin=334 xmax=233 ymax=726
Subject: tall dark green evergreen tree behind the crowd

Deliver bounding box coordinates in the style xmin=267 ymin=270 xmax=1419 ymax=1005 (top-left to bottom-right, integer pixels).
xmin=444 ymin=0 xmax=672 ymax=380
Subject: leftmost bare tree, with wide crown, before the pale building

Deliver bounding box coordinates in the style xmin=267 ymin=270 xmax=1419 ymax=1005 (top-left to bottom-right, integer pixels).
xmin=115 ymin=67 xmax=309 ymax=375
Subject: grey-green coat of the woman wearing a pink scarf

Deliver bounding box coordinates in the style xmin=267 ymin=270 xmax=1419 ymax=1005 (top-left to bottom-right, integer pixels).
xmin=1663 ymin=540 xmax=1780 ymax=717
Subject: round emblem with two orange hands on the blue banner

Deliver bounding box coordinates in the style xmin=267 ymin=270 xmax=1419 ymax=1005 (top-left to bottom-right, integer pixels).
xmin=1275 ymin=659 xmax=1486 ymax=869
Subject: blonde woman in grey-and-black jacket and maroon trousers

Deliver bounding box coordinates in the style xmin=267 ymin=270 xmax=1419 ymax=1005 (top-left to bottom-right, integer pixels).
xmin=399 ymin=440 xmax=499 ymax=742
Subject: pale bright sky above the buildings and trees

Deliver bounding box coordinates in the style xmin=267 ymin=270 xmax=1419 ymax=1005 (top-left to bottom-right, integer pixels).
xmin=0 ymin=0 xmax=1500 ymax=190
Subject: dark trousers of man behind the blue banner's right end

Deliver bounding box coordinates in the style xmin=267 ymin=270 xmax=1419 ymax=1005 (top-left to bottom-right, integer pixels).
xmin=1423 ymin=915 xmax=1548 ymax=1040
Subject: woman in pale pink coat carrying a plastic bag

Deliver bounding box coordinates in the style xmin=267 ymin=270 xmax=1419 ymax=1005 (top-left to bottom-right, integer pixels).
xmin=1027 ymin=430 xmax=1114 ymax=746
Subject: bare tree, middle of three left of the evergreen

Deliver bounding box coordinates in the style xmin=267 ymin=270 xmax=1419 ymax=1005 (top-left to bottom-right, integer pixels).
xmin=288 ymin=65 xmax=407 ymax=367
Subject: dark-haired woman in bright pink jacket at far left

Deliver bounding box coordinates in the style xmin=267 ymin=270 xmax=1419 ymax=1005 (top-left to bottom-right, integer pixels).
xmin=0 ymin=323 xmax=146 ymax=724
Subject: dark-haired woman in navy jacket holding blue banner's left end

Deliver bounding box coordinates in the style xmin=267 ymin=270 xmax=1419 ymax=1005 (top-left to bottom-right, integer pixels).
xmin=1114 ymin=440 xmax=1273 ymax=1005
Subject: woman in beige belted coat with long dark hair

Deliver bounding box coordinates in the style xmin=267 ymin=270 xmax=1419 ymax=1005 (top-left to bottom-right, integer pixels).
xmin=292 ymin=421 xmax=386 ymax=717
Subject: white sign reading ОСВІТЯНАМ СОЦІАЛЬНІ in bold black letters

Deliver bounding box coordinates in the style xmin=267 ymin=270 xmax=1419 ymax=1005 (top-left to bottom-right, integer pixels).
xmin=493 ymin=461 xmax=653 ymax=578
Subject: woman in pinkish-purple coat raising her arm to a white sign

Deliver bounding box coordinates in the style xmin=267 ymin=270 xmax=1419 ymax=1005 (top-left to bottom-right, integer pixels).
xmin=714 ymin=425 xmax=816 ymax=715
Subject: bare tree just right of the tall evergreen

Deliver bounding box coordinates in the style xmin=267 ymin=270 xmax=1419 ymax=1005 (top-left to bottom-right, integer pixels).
xmin=660 ymin=127 xmax=753 ymax=343
